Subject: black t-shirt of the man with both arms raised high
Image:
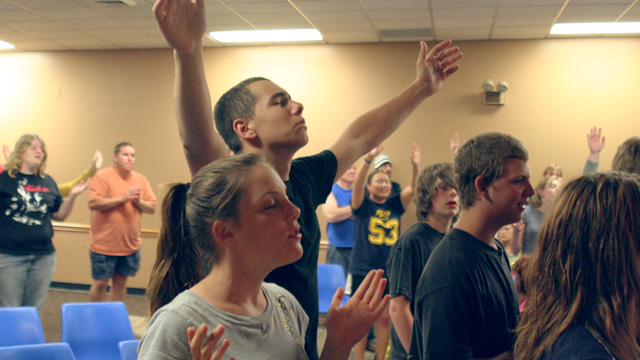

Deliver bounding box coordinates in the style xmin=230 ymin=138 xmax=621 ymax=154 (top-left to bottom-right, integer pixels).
xmin=264 ymin=150 xmax=338 ymax=360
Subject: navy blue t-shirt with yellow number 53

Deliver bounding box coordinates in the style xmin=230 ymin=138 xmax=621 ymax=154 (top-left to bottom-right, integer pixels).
xmin=349 ymin=195 xmax=404 ymax=276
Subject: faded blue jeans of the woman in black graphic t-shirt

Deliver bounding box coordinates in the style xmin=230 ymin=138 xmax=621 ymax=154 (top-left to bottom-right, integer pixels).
xmin=0 ymin=253 xmax=56 ymax=310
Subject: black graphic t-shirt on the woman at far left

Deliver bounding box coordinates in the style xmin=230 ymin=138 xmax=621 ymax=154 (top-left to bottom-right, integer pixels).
xmin=0 ymin=171 xmax=62 ymax=255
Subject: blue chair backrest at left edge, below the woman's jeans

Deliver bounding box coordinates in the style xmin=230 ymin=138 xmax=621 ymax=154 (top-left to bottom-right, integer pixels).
xmin=0 ymin=306 xmax=44 ymax=346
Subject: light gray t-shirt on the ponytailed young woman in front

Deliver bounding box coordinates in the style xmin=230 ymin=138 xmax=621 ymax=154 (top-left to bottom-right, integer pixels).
xmin=138 ymin=283 xmax=309 ymax=360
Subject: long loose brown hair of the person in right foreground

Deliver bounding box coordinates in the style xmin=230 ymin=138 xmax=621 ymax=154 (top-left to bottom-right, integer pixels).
xmin=514 ymin=172 xmax=640 ymax=359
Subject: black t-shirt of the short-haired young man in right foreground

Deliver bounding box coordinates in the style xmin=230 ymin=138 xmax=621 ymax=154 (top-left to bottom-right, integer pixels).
xmin=409 ymin=229 xmax=519 ymax=359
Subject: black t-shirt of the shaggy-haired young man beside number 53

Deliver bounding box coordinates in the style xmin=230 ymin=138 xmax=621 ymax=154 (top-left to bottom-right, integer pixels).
xmin=387 ymin=222 xmax=444 ymax=360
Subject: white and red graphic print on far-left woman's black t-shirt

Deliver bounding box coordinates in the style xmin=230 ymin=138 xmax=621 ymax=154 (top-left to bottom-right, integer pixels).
xmin=5 ymin=179 xmax=51 ymax=226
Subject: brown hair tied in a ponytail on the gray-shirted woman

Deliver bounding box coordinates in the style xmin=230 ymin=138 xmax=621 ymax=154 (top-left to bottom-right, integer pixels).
xmin=147 ymin=154 xmax=267 ymax=316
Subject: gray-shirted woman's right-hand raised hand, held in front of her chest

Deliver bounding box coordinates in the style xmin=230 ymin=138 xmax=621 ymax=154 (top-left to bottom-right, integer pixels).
xmin=321 ymin=270 xmax=389 ymax=359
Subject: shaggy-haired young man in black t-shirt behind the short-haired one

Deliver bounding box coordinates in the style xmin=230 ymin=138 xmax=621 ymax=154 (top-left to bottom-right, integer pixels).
xmin=387 ymin=163 xmax=460 ymax=360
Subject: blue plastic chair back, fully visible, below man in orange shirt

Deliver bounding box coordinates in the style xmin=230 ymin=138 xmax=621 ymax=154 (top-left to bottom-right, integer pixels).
xmin=61 ymin=302 xmax=135 ymax=360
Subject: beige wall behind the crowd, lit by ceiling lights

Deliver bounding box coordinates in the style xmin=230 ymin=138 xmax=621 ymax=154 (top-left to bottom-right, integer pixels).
xmin=0 ymin=38 xmax=640 ymax=287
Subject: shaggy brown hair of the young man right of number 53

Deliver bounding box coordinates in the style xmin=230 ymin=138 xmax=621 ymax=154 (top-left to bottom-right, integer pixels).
xmin=413 ymin=163 xmax=456 ymax=221
